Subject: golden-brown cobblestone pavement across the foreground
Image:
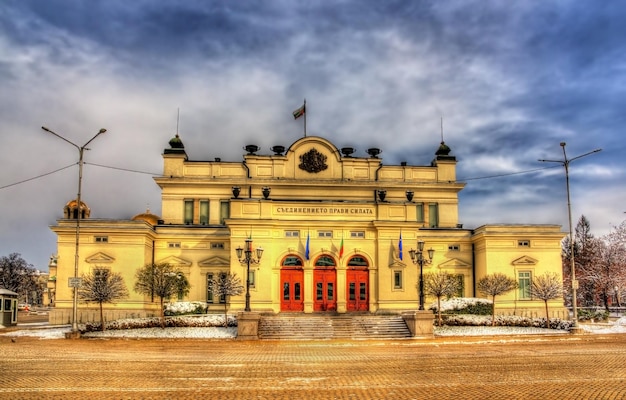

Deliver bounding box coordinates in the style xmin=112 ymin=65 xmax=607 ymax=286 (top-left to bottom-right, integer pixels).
xmin=0 ymin=335 xmax=626 ymax=400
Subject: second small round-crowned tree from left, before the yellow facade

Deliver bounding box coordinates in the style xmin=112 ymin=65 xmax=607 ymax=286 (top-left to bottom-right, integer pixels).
xmin=135 ymin=263 xmax=191 ymax=328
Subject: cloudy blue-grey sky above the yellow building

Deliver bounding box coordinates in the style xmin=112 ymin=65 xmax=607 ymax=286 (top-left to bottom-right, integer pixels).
xmin=0 ymin=0 xmax=626 ymax=270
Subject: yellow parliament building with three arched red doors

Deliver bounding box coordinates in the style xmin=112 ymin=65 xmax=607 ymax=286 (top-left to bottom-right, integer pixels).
xmin=51 ymin=135 xmax=566 ymax=323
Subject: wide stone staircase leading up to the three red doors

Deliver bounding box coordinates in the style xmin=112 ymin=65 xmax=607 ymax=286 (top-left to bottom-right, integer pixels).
xmin=259 ymin=313 xmax=411 ymax=340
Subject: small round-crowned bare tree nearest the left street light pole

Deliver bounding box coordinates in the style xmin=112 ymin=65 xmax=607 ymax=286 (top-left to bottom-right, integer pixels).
xmin=78 ymin=268 xmax=128 ymax=331
